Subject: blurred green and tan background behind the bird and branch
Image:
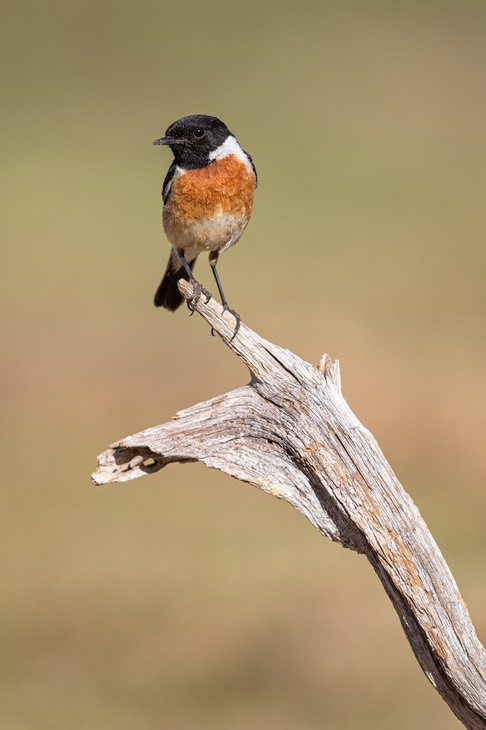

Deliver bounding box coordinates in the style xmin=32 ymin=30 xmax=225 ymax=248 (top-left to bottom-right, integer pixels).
xmin=0 ymin=0 xmax=486 ymax=730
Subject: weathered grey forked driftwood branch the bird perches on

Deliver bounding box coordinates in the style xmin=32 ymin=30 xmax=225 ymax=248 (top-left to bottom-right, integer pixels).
xmin=93 ymin=281 xmax=486 ymax=728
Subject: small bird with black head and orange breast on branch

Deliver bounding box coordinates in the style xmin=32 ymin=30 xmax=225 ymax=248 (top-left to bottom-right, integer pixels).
xmin=154 ymin=114 xmax=257 ymax=332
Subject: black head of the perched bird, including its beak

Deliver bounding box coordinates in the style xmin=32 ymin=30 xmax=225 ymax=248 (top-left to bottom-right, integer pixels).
xmin=154 ymin=114 xmax=231 ymax=169
